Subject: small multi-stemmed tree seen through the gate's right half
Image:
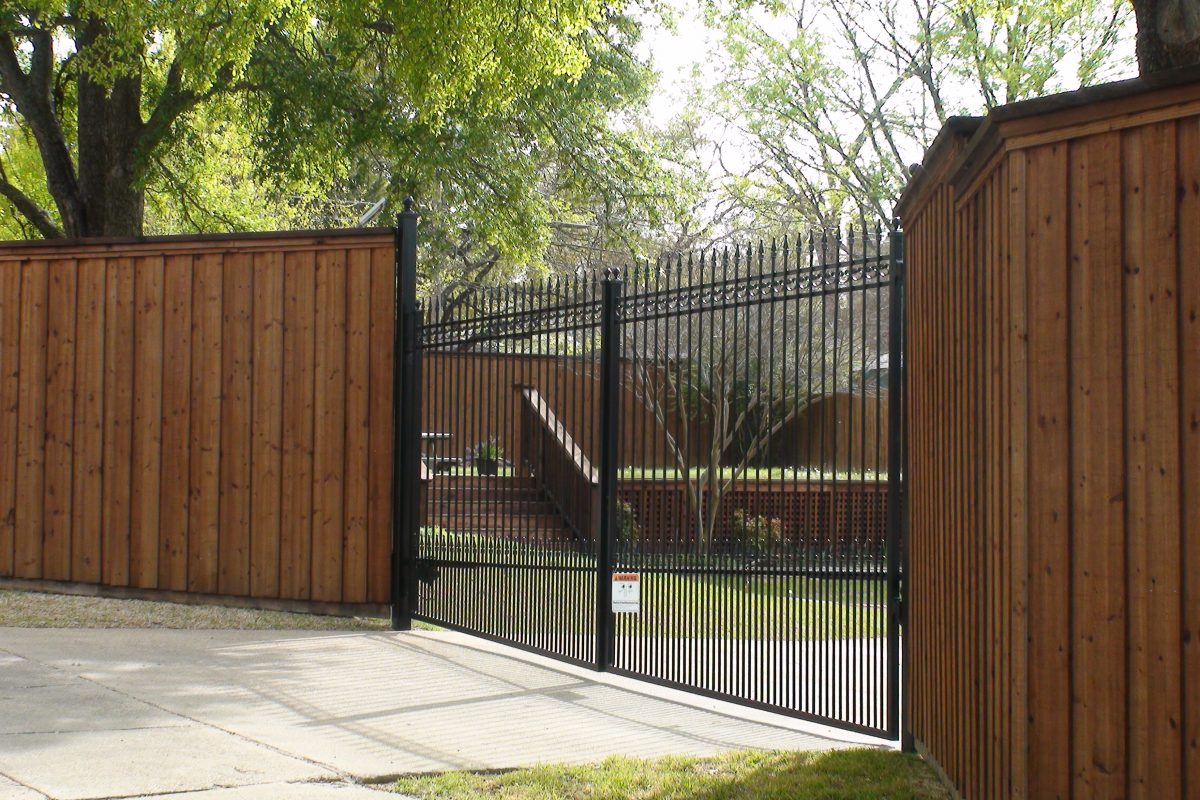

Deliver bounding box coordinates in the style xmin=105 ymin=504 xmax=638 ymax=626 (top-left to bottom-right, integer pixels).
xmin=624 ymin=231 xmax=888 ymax=555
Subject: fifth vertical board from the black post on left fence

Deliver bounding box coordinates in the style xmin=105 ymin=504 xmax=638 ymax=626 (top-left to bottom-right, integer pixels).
xmin=250 ymin=253 xmax=283 ymax=597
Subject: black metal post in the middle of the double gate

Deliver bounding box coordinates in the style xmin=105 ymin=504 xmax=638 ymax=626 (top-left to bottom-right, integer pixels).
xmin=595 ymin=271 xmax=622 ymax=670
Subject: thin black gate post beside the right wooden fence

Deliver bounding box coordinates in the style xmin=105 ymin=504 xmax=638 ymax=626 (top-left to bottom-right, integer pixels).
xmin=886 ymin=219 xmax=907 ymax=738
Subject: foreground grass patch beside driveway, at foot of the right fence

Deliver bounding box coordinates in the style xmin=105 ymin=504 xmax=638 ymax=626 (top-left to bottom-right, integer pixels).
xmin=391 ymin=750 xmax=949 ymax=800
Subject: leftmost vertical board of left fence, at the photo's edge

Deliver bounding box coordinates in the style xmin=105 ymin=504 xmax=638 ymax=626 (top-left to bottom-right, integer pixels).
xmin=0 ymin=261 xmax=22 ymax=578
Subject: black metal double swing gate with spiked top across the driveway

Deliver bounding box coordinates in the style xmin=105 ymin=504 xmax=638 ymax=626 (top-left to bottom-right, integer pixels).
xmin=394 ymin=205 xmax=904 ymax=738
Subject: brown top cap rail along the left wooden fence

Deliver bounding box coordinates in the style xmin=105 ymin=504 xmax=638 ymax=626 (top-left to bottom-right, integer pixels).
xmin=0 ymin=228 xmax=396 ymax=260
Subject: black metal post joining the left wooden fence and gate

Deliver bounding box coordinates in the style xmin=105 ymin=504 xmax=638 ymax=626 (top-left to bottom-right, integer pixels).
xmin=391 ymin=197 xmax=421 ymax=631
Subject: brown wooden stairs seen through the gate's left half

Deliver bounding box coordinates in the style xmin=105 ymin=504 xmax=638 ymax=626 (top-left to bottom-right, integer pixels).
xmin=428 ymin=475 xmax=580 ymax=546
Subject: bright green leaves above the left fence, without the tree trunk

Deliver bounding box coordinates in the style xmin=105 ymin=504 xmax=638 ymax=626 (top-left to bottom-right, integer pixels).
xmin=0 ymin=0 xmax=686 ymax=277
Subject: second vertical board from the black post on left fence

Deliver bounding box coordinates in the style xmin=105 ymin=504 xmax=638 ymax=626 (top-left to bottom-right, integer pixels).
xmin=342 ymin=247 xmax=371 ymax=603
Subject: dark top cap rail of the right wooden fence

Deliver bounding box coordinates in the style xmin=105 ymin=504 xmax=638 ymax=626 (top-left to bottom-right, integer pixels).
xmin=895 ymin=66 xmax=1200 ymax=217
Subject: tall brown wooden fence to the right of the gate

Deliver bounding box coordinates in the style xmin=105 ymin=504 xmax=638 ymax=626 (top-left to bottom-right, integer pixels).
xmin=899 ymin=65 xmax=1200 ymax=800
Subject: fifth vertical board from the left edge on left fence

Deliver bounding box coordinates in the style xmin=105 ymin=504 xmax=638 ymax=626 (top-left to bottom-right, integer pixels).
xmin=101 ymin=258 xmax=134 ymax=585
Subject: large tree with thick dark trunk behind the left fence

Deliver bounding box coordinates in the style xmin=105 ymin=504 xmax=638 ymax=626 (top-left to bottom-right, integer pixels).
xmin=0 ymin=0 xmax=604 ymax=237
